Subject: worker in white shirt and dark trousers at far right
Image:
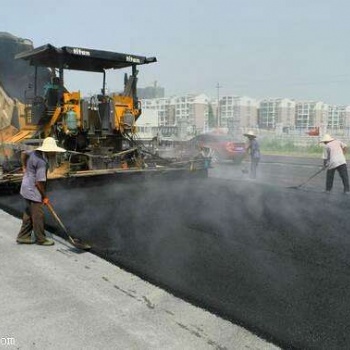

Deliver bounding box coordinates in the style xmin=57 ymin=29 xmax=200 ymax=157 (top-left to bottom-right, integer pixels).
xmin=320 ymin=134 xmax=349 ymax=194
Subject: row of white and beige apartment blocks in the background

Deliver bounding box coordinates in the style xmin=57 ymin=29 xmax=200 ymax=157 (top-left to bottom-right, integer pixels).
xmin=141 ymin=94 xmax=350 ymax=134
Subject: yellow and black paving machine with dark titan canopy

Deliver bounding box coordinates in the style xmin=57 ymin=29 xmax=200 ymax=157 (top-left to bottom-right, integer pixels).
xmin=2 ymin=44 xmax=156 ymax=173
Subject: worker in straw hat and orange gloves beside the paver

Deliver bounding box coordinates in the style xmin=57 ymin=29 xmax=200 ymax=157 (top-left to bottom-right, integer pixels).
xmin=17 ymin=137 xmax=66 ymax=246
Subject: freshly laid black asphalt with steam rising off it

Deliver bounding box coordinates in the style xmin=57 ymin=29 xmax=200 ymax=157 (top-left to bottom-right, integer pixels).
xmin=1 ymin=157 xmax=350 ymax=350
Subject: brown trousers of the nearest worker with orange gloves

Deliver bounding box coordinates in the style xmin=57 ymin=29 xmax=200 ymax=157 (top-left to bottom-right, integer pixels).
xmin=17 ymin=199 xmax=46 ymax=243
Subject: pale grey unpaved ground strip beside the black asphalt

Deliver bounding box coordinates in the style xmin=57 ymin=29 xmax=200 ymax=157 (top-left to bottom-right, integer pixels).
xmin=0 ymin=211 xmax=277 ymax=350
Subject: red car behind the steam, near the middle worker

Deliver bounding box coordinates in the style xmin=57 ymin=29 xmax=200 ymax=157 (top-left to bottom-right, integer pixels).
xmin=180 ymin=133 xmax=245 ymax=164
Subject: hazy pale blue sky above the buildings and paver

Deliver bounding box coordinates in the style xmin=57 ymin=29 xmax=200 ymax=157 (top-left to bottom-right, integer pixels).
xmin=0 ymin=0 xmax=350 ymax=105
